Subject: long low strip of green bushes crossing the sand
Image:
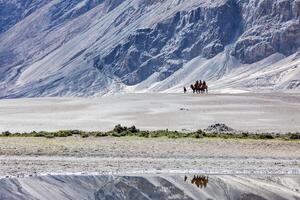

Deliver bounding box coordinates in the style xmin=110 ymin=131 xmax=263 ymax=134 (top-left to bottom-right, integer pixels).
xmin=0 ymin=124 xmax=300 ymax=140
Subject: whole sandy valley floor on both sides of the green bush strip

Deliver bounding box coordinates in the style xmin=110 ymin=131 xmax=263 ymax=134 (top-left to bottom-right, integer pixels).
xmin=0 ymin=93 xmax=300 ymax=181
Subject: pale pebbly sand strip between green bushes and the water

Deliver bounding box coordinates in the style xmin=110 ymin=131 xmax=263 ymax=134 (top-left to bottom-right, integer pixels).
xmin=0 ymin=136 xmax=300 ymax=177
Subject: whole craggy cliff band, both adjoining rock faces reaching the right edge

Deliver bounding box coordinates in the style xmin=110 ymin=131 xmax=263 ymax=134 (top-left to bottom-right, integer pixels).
xmin=94 ymin=0 xmax=300 ymax=85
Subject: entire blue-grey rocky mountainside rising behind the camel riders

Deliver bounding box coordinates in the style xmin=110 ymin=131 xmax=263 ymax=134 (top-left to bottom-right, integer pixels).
xmin=0 ymin=0 xmax=300 ymax=98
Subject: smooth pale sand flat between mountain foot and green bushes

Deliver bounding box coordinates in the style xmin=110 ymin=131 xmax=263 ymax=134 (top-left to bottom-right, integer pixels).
xmin=0 ymin=93 xmax=300 ymax=132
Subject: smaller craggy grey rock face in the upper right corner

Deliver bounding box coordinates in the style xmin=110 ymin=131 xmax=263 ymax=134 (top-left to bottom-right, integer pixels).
xmin=232 ymin=0 xmax=300 ymax=63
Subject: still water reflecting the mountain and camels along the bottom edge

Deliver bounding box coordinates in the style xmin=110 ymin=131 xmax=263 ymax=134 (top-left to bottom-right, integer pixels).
xmin=0 ymin=174 xmax=300 ymax=200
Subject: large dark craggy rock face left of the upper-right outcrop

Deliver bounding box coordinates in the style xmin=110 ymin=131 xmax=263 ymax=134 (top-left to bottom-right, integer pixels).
xmin=94 ymin=1 xmax=240 ymax=85
